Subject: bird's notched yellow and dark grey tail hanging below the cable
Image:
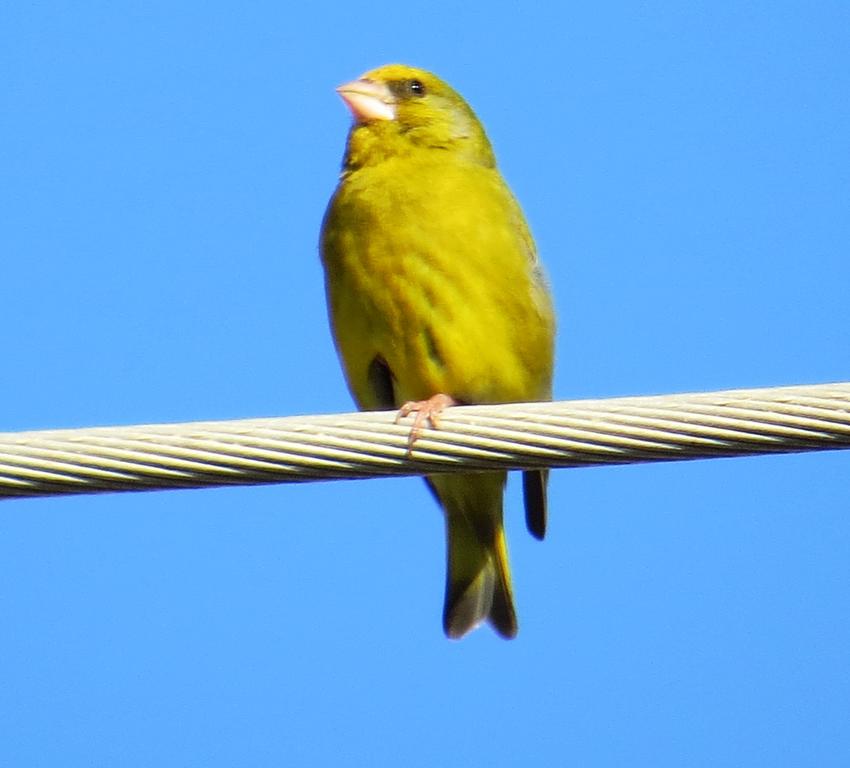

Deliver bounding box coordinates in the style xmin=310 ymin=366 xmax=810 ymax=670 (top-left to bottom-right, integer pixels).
xmin=428 ymin=472 xmax=517 ymax=638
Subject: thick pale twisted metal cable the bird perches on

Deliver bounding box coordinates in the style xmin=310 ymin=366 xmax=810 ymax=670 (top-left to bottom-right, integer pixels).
xmin=0 ymin=382 xmax=850 ymax=498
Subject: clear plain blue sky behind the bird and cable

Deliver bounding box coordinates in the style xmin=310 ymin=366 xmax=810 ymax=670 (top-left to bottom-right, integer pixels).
xmin=0 ymin=1 xmax=850 ymax=768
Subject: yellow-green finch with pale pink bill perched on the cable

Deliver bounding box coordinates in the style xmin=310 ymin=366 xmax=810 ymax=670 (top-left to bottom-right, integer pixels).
xmin=319 ymin=64 xmax=556 ymax=638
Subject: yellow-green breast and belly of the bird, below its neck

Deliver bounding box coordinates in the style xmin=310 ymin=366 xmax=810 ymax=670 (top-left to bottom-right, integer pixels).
xmin=323 ymin=158 xmax=552 ymax=402
